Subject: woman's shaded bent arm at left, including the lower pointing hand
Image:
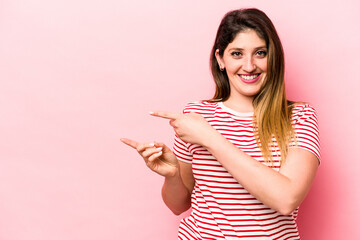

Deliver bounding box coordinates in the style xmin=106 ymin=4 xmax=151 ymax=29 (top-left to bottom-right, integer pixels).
xmin=121 ymin=138 xmax=195 ymax=215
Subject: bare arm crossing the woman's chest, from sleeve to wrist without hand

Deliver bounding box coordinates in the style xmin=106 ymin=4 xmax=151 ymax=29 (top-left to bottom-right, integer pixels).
xmin=203 ymin=132 xmax=318 ymax=215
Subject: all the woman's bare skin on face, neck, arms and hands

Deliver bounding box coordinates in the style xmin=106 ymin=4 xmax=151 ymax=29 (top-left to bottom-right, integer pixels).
xmin=121 ymin=30 xmax=318 ymax=215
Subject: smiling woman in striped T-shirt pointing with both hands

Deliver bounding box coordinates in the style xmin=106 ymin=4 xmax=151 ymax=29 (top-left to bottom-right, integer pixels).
xmin=122 ymin=9 xmax=320 ymax=239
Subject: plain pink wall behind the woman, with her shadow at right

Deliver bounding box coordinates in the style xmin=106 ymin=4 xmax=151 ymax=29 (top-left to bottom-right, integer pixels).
xmin=0 ymin=0 xmax=360 ymax=240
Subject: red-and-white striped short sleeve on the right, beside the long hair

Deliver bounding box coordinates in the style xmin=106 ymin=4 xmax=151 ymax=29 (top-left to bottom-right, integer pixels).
xmin=290 ymin=104 xmax=320 ymax=162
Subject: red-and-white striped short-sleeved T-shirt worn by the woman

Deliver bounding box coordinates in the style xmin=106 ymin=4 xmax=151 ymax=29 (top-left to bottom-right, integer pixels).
xmin=174 ymin=102 xmax=320 ymax=240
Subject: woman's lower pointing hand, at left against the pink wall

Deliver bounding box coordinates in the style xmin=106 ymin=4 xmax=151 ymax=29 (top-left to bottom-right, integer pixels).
xmin=120 ymin=138 xmax=179 ymax=177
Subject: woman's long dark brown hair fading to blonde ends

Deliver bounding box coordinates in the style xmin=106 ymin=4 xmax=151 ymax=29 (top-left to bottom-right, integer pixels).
xmin=209 ymin=8 xmax=294 ymax=163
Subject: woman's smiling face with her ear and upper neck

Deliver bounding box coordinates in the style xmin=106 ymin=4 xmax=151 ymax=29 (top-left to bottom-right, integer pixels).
xmin=215 ymin=29 xmax=267 ymax=103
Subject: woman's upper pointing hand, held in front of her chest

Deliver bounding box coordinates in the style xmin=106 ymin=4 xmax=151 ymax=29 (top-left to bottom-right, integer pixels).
xmin=150 ymin=112 xmax=218 ymax=146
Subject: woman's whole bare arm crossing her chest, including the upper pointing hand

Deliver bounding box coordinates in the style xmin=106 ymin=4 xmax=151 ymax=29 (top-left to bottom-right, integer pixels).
xmin=152 ymin=112 xmax=318 ymax=215
